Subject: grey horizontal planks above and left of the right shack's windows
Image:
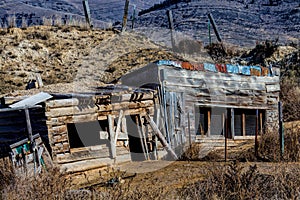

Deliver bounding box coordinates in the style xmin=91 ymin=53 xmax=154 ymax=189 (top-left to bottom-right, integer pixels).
xmin=161 ymin=66 xmax=280 ymax=138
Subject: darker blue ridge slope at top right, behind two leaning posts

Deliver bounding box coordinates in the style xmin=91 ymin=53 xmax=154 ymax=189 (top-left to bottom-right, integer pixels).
xmin=137 ymin=0 xmax=300 ymax=46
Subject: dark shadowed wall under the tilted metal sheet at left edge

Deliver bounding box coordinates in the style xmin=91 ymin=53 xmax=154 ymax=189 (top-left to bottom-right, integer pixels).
xmin=0 ymin=108 xmax=48 ymax=157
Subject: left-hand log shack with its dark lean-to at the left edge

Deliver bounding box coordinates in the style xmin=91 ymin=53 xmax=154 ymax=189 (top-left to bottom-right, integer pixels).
xmin=0 ymin=86 xmax=163 ymax=176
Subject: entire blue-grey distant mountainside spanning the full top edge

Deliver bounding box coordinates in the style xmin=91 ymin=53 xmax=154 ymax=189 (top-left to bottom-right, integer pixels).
xmin=0 ymin=0 xmax=300 ymax=47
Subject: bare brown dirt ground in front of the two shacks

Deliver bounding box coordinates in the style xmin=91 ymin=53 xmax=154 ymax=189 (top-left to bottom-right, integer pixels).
xmin=88 ymin=161 xmax=300 ymax=199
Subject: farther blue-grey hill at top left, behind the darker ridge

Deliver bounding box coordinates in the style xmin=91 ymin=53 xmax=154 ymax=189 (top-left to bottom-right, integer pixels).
xmin=0 ymin=0 xmax=160 ymax=28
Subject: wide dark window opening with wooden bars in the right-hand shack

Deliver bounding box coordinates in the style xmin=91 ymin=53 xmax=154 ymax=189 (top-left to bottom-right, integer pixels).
xmin=195 ymin=106 xmax=265 ymax=138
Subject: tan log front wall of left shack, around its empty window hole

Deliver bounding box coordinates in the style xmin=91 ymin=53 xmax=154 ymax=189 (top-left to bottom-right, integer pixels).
xmin=46 ymin=92 xmax=155 ymax=164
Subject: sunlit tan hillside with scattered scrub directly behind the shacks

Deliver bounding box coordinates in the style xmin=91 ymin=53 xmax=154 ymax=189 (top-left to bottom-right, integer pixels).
xmin=0 ymin=26 xmax=211 ymax=94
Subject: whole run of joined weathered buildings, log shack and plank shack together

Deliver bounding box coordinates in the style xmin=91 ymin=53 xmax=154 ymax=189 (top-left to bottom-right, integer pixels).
xmin=0 ymin=61 xmax=280 ymax=179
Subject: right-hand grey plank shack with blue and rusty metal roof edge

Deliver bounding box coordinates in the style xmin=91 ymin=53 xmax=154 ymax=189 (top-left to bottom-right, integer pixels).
xmin=120 ymin=60 xmax=280 ymax=147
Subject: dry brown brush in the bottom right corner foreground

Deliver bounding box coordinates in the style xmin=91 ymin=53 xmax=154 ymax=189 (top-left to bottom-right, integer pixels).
xmin=179 ymin=162 xmax=300 ymax=200
